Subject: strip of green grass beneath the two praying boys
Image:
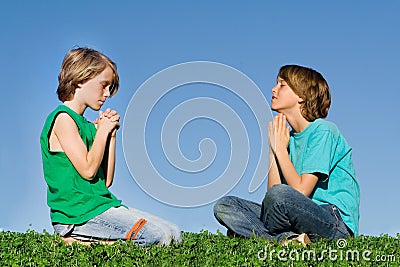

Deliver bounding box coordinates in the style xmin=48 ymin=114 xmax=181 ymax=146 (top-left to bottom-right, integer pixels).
xmin=0 ymin=231 xmax=400 ymax=266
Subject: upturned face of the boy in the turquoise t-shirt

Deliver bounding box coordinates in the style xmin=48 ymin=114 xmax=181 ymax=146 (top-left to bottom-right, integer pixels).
xmin=271 ymin=77 xmax=302 ymax=114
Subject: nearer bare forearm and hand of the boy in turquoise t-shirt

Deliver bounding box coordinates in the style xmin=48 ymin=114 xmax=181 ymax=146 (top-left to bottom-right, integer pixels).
xmin=273 ymin=114 xmax=318 ymax=196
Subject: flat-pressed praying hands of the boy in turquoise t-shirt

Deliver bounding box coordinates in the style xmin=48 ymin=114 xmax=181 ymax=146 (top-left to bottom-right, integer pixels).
xmin=268 ymin=113 xmax=290 ymax=154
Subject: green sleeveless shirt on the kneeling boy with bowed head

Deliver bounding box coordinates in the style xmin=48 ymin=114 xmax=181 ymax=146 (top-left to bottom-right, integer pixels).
xmin=40 ymin=105 xmax=121 ymax=224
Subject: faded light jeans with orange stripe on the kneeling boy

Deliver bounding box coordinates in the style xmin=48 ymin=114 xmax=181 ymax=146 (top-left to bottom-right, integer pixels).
xmin=53 ymin=206 xmax=182 ymax=245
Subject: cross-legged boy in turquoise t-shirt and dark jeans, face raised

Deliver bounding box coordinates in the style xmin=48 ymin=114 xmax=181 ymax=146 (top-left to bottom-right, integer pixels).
xmin=214 ymin=65 xmax=360 ymax=243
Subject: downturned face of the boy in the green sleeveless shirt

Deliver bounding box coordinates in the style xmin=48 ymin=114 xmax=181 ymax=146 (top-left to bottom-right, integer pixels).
xmin=75 ymin=67 xmax=114 ymax=110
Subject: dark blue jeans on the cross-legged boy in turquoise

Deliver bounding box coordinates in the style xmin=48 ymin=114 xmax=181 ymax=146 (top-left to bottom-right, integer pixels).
xmin=214 ymin=184 xmax=352 ymax=241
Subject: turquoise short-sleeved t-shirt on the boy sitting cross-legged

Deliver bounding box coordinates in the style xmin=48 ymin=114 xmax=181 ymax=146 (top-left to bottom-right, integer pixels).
xmin=289 ymin=119 xmax=360 ymax=236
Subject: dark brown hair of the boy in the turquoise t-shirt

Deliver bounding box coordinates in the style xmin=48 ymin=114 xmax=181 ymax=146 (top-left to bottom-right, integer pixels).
xmin=278 ymin=65 xmax=331 ymax=121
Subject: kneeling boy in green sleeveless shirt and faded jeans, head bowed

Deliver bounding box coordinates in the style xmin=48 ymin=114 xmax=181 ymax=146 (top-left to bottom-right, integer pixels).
xmin=40 ymin=48 xmax=181 ymax=245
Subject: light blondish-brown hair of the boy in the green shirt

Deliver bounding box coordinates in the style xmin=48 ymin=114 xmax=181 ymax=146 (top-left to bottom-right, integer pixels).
xmin=57 ymin=47 xmax=119 ymax=102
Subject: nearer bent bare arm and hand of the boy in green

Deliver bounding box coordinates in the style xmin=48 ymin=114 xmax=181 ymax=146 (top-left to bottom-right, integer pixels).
xmin=53 ymin=110 xmax=119 ymax=180
